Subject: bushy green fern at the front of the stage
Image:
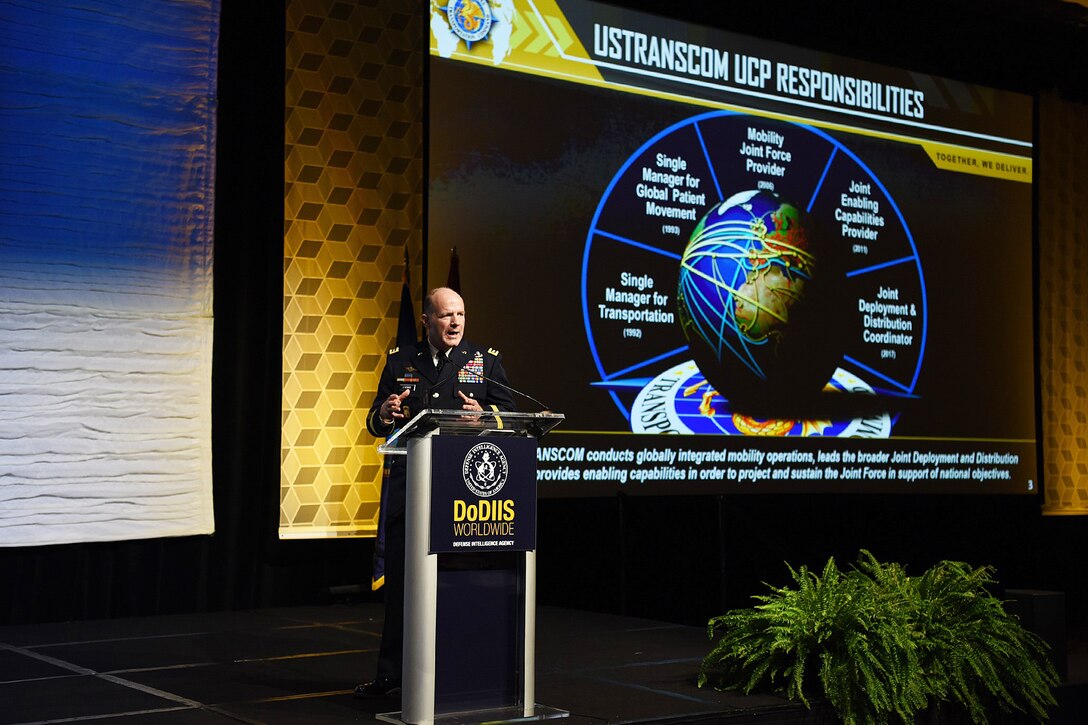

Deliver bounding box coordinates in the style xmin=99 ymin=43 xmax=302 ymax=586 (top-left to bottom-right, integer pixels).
xmin=698 ymin=551 xmax=1058 ymax=724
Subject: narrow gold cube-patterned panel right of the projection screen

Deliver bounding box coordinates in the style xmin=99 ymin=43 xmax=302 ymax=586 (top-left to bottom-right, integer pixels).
xmin=1039 ymin=94 xmax=1088 ymax=516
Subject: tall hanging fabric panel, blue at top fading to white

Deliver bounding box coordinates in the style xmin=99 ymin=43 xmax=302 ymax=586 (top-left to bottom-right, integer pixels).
xmin=0 ymin=0 xmax=219 ymax=546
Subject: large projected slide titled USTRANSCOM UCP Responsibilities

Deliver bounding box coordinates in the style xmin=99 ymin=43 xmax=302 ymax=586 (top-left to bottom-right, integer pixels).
xmin=426 ymin=0 xmax=1038 ymax=495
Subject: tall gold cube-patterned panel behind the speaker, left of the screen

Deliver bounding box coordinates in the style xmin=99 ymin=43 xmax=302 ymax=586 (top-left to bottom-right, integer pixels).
xmin=280 ymin=0 xmax=423 ymax=538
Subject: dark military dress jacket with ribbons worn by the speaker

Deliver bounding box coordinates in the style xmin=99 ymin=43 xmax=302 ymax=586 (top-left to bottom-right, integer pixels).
xmin=367 ymin=340 xmax=516 ymax=516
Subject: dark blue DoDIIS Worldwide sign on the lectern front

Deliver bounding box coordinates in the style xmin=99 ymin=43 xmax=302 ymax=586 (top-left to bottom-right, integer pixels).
xmin=430 ymin=435 xmax=536 ymax=554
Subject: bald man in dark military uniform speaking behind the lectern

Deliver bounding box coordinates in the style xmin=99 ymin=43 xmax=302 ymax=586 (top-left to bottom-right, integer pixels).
xmin=355 ymin=287 xmax=515 ymax=698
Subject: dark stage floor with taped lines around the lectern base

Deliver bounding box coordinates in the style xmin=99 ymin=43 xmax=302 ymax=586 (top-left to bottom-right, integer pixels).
xmin=0 ymin=604 xmax=1088 ymax=725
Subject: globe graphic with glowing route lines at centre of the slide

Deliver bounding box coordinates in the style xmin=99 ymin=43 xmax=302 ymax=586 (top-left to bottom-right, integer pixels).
xmin=677 ymin=191 xmax=842 ymax=414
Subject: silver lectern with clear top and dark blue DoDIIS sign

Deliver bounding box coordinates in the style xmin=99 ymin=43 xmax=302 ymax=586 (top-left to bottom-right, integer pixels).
xmin=378 ymin=409 xmax=568 ymax=725
